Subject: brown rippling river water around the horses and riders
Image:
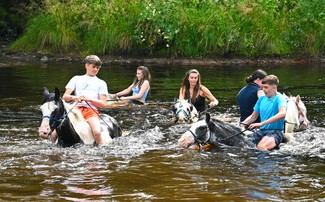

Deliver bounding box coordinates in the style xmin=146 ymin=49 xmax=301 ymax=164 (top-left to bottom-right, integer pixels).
xmin=0 ymin=63 xmax=325 ymax=201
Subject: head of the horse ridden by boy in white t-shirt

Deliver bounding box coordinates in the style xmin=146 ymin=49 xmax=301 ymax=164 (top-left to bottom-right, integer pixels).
xmin=38 ymin=88 xmax=64 ymax=137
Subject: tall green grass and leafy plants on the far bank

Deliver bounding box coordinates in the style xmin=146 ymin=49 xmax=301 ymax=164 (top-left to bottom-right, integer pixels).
xmin=11 ymin=0 xmax=325 ymax=57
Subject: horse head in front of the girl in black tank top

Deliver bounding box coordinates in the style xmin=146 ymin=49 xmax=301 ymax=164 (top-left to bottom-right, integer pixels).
xmin=172 ymin=100 xmax=199 ymax=123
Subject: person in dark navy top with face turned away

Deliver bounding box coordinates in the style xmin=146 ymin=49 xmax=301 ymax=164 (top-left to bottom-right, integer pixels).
xmin=237 ymin=69 xmax=267 ymax=123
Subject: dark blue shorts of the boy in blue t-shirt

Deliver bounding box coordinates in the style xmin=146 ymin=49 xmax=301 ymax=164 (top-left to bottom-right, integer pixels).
xmin=252 ymin=130 xmax=286 ymax=148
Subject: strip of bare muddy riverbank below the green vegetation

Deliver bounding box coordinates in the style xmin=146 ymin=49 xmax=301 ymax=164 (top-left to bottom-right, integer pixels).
xmin=0 ymin=43 xmax=325 ymax=67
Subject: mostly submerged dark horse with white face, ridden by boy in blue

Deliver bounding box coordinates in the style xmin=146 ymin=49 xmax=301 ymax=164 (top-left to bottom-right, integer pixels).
xmin=178 ymin=113 xmax=255 ymax=149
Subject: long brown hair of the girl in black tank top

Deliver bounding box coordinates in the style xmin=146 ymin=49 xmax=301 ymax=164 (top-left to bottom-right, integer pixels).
xmin=181 ymin=69 xmax=201 ymax=103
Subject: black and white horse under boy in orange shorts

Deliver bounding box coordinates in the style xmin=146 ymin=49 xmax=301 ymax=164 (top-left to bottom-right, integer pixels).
xmin=39 ymin=88 xmax=122 ymax=147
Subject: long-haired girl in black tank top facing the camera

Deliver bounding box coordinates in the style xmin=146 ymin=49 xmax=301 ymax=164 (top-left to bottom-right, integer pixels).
xmin=179 ymin=69 xmax=219 ymax=112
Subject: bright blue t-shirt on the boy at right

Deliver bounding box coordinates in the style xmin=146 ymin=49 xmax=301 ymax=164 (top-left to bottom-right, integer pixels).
xmin=254 ymin=92 xmax=287 ymax=130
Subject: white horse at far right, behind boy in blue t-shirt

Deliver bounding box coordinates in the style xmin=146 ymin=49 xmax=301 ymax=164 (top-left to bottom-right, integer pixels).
xmin=283 ymin=94 xmax=309 ymax=140
